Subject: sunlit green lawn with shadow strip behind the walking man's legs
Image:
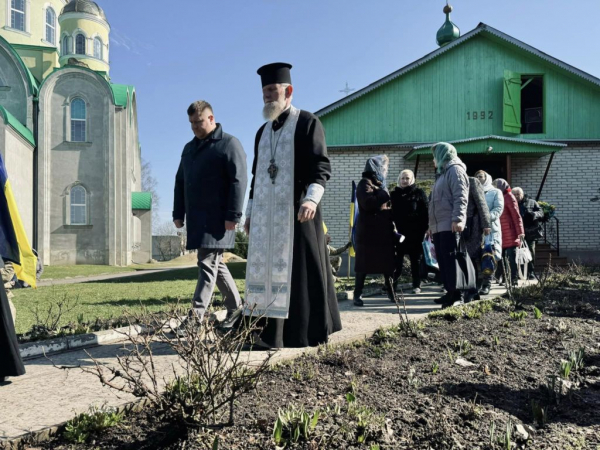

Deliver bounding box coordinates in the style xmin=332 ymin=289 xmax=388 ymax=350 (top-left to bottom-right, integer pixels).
xmin=13 ymin=262 xmax=246 ymax=334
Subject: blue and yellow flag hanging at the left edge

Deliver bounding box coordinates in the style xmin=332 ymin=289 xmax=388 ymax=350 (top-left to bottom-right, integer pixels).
xmin=0 ymin=155 xmax=37 ymax=287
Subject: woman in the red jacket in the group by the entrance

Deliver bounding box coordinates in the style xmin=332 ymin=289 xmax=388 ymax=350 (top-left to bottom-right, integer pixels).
xmin=493 ymin=178 xmax=525 ymax=286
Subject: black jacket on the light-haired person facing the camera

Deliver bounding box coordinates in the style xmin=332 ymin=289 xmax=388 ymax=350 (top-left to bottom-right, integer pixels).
xmin=390 ymin=184 xmax=429 ymax=248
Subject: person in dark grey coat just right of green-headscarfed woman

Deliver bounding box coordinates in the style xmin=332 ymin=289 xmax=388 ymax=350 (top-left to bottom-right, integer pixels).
xmin=462 ymin=177 xmax=492 ymax=303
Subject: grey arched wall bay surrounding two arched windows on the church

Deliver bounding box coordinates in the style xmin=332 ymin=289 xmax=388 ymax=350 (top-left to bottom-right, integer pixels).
xmin=40 ymin=69 xmax=114 ymax=264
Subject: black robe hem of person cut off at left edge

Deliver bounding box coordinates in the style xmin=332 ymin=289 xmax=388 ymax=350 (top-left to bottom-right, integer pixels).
xmin=0 ymin=258 xmax=25 ymax=378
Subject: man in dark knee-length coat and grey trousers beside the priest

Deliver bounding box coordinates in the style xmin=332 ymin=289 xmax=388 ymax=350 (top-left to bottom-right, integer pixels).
xmin=173 ymin=101 xmax=247 ymax=330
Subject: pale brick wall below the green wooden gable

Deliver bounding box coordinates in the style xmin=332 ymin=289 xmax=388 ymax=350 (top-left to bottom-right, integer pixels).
xmin=322 ymin=144 xmax=600 ymax=252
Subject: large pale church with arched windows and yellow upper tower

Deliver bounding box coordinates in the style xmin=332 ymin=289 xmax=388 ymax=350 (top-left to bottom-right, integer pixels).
xmin=0 ymin=0 xmax=152 ymax=266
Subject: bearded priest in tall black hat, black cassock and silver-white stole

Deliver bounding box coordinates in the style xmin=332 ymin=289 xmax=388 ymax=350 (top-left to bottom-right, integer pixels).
xmin=245 ymin=63 xmax=342 ymax=348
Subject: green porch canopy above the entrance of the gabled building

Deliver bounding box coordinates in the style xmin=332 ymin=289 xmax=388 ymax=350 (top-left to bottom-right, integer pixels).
xmin=404 ymin=136 xmax=567 ymax=160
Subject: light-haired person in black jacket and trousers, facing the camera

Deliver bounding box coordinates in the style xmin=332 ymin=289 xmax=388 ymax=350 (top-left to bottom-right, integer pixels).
xmin=390 ymin=169 xmax=429 ymax=294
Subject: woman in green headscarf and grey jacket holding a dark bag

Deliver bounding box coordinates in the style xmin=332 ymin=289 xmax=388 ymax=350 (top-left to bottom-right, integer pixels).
xmin=429 ymin=142 xmax=469 ymax=307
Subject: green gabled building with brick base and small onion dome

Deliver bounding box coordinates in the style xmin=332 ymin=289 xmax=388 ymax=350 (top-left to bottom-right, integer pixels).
xmin=316 ymin=7 xmax=600 ymax=259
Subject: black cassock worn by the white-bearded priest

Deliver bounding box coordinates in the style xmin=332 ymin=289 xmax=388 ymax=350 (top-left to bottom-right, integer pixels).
xmin=250 ymin=109 xmax=342 ymax=348
